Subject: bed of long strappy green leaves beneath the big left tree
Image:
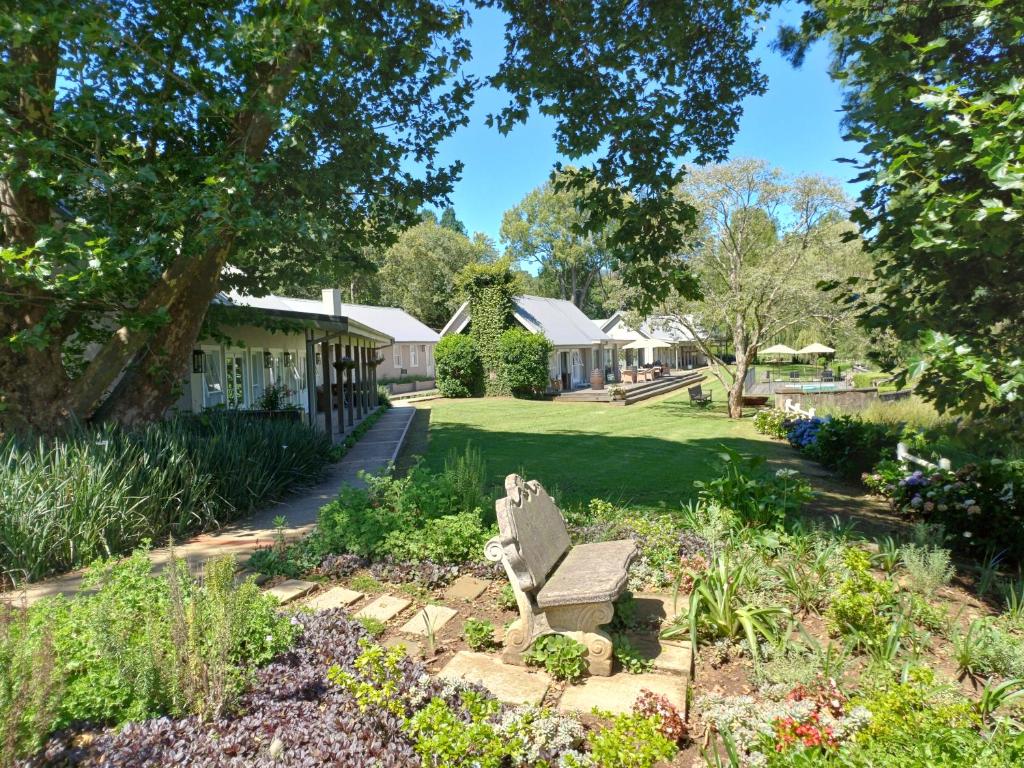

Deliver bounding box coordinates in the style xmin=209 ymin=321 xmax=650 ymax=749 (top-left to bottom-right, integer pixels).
xmin=0 ymin=413 xmax=330 ymax=581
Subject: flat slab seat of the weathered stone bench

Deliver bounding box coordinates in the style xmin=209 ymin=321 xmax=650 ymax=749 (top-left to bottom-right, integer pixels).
xmin=537 ymin=539 xmax=637 ymax=608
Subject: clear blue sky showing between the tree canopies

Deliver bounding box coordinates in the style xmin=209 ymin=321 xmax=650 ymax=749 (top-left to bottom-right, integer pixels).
xmin=421 ymin=3 xmax=856 ymax=242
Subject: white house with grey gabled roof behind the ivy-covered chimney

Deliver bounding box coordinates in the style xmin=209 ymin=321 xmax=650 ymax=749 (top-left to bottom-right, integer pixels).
xmin=441 ymin=296 xmax=625 ymax=390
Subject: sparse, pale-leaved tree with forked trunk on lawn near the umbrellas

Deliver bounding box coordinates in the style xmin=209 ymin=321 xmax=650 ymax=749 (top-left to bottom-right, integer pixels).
xmin=669 ymin=160 xmax=845 ymax=418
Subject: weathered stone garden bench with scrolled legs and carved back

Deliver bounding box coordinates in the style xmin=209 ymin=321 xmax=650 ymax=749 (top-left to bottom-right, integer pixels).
xmin=484 ymin=474 xmax=637 ymax=675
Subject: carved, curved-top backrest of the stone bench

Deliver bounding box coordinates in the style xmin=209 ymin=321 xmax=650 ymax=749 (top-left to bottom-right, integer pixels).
xmin=495 ymin=474 xmax=570 ymax=592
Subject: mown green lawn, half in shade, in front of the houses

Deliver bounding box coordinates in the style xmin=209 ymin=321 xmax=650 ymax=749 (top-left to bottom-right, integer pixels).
xmin=421 ymin=382 xmax=792 ymax=509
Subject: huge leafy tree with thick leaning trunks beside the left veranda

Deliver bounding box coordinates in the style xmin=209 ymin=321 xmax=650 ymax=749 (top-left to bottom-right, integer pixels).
xmin=0 ymin=0 xmax=471 ymax=429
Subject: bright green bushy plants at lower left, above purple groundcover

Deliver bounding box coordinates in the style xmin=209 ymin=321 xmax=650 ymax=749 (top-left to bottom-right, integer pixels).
xmin=0 ymin=551 xmax=296 ymax=752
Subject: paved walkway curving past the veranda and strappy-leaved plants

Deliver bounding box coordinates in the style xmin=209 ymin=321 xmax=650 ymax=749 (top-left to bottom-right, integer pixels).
xmin=0 ymin=406 xmax=416 ymax=604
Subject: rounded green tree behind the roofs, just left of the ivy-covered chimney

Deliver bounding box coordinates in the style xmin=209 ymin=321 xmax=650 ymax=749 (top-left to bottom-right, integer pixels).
xmin=377 ymin=220 xmax=498 ymax=328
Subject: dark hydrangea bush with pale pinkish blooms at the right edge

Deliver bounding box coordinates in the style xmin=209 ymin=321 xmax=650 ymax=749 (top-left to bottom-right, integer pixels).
xmin=863 ymin=460 xmax=1024 ymax=562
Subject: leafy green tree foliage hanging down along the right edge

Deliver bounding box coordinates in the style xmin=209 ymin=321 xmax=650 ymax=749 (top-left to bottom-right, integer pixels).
xmin=780 ymin=0 xmax=1024 ymax=431
